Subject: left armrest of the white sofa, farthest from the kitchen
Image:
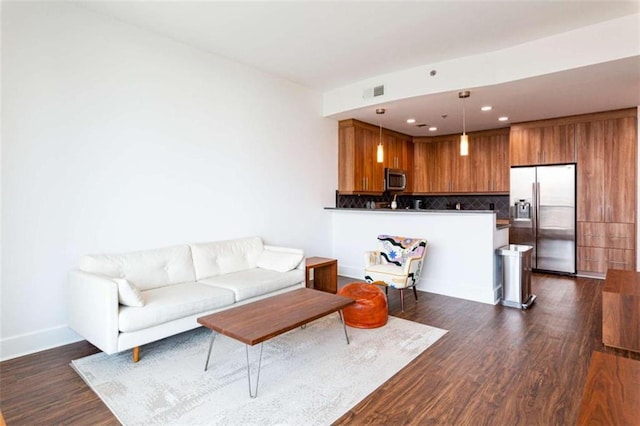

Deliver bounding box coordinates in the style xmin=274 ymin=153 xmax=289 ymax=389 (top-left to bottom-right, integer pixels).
xmin=68 ymin=270 xmax=120 ymax=354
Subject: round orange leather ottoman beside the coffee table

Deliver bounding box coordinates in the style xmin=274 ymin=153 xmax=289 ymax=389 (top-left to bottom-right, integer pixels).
xmin=338 ymin=283 xmax=389 ymax=328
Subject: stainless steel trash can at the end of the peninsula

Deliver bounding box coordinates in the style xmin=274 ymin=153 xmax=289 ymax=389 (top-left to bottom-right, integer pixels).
xmin=496 ymin=244 xmax=536 ymax=309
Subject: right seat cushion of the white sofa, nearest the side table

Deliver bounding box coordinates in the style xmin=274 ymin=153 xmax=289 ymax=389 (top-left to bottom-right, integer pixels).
xmin=198 ymin=268 xmax=304 ymax=302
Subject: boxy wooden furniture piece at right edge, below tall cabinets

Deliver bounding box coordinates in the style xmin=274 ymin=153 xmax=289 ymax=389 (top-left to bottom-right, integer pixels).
xmin=602 ymin=269 xmax=640 ymax=352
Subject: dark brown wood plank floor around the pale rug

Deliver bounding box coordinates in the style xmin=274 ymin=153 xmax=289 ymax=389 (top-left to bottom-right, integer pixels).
xmin=0 ymin=274 xmax=640 ymax=426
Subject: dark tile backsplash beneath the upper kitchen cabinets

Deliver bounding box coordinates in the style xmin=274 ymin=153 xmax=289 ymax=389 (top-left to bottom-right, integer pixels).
xmin=336 ymin=193 xmax=509 ymax=219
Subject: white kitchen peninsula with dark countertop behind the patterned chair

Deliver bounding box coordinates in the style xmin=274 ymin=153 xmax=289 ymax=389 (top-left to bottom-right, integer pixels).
xmin=326 ymin=208 xmax=509 ymax=304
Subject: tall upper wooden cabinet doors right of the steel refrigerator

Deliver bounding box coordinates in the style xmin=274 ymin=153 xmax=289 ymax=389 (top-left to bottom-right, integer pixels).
xmin=576 ymin=114 xmax=637 ymax=223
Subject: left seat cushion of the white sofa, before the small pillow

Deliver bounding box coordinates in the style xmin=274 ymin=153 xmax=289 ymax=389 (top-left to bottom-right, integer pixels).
xmin=118 ymin=282 xmax=235 ymax=332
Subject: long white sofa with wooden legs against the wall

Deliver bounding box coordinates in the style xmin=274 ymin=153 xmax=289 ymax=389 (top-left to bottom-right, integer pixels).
xmin=69 ymin=237 xmax=305 ymax=361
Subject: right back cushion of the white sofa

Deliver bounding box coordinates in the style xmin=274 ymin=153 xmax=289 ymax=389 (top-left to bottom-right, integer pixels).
xmin=191 ymin=237 xmax=264 ymax=280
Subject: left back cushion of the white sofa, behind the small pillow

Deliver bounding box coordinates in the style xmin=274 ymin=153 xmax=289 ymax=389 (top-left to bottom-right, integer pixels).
xmin=80 ymin=245 xmax=195 ymax=290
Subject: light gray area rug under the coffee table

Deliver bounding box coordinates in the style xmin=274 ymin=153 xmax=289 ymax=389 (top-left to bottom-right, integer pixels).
xmin=71 ymin=313 xmax=447 ymax=425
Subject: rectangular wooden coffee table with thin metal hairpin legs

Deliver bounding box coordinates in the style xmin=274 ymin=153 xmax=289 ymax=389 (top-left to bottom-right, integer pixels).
xmin=198 ymin=288 xmax=355 ymax=398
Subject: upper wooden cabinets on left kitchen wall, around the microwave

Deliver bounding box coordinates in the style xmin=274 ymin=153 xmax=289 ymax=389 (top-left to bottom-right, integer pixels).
xmin=338 ymin=119 xmax=413 ymax=194
